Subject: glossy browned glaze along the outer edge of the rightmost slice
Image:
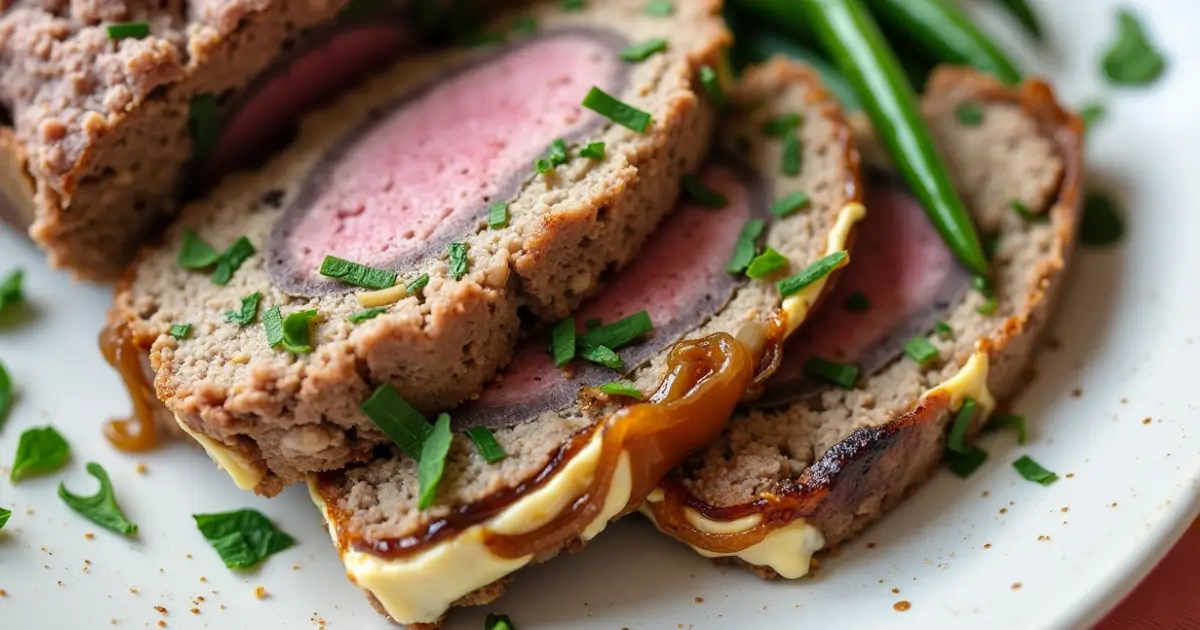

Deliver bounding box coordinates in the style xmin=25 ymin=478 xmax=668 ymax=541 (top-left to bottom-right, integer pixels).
xmin=648 ymin=68 xmax=1084 ymax=559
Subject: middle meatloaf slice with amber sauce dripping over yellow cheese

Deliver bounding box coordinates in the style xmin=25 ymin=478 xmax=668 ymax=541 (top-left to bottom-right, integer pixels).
xmin=310 ymin=61 xmax=863 ymax=628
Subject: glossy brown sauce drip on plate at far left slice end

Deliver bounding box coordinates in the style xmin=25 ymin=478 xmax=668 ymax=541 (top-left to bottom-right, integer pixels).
xmin=100 ymin=323 xmax=162 ymax=452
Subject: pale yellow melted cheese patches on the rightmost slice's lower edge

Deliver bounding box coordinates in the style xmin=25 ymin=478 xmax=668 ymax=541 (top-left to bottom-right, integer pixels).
xmin=640 ymin=347 xmax=996 ymax=580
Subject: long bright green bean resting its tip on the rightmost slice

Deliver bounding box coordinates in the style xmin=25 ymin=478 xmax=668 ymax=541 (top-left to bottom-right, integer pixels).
xmin=791 ymin=0 xmax=988 ymax=275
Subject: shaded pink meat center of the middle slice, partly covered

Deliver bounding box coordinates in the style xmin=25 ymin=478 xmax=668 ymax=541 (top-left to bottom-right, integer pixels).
xmin=479 ymin=166 xmax=751 ymax=407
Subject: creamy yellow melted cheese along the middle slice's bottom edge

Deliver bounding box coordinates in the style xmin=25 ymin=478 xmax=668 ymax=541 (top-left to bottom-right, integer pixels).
xmin=308 ymin=432 xmax=632 ymax=624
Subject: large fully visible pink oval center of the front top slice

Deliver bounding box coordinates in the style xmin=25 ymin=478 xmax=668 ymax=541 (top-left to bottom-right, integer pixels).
xmin=277 ymin=35 xmax=620 ymax=270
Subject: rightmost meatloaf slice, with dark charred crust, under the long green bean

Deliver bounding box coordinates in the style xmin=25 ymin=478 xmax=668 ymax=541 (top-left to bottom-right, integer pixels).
xmin=643 ymin=68 xmax=1082 ymax=577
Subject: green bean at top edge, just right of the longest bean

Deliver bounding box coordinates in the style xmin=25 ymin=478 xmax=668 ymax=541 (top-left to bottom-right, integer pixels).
xmin=866 ymin=0 xmax=1021 ymax=84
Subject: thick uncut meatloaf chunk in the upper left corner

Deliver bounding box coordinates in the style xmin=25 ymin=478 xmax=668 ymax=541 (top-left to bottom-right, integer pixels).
xmin=0 ymin=0 xmax=487 ymax=280
